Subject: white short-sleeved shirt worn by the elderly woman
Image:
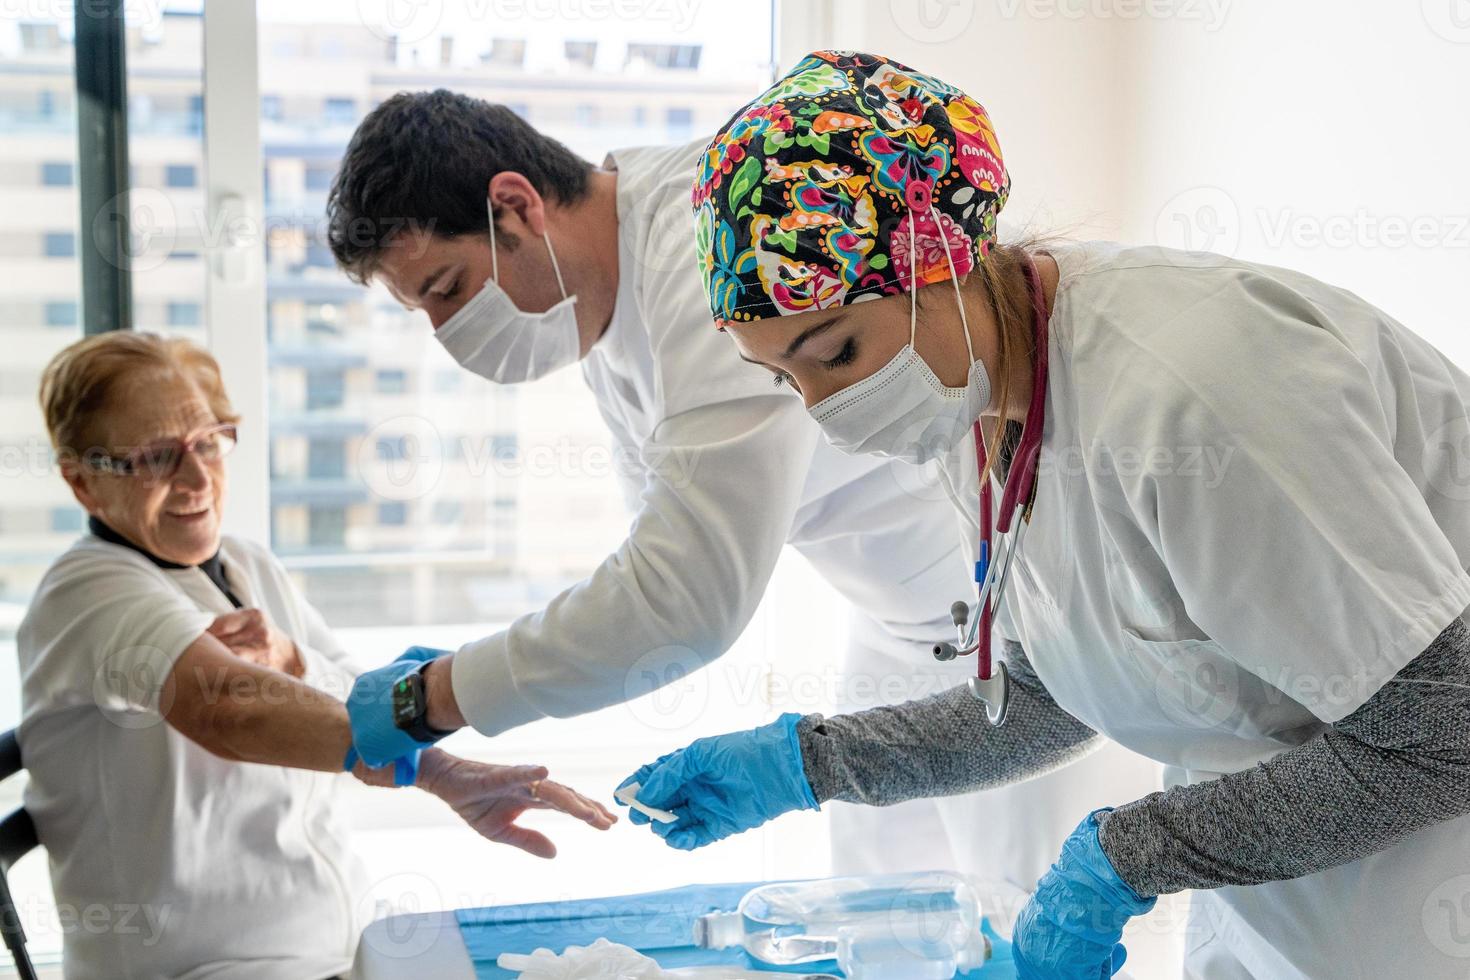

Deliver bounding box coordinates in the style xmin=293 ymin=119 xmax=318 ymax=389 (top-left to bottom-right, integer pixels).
xmin=18 ymin=535 xmax=366 ymax=980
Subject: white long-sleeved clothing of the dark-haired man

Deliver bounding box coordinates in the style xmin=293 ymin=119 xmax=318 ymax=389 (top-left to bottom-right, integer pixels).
xmin=453 ymin=140 xmax=1157 ymax=886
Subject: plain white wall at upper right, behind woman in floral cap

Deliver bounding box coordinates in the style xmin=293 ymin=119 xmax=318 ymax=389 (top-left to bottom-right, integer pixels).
xmin=811 ymin=0 xmax=1470 ymax=364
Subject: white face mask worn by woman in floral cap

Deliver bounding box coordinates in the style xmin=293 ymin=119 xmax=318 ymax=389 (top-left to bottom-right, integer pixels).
xmin=809 ymin=204 xmax=991 ymax=463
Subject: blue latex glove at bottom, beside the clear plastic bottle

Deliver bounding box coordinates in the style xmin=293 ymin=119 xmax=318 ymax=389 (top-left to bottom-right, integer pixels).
xmin=1011 ymin=810 xmax=1157 ymax=980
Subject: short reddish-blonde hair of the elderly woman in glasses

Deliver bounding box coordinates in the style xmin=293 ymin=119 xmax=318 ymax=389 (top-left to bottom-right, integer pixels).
xmin=41 ymin=331 xmax=240 ymax=458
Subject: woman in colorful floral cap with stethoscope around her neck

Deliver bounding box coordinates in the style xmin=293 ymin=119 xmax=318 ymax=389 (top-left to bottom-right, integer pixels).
xmin=614 ymin=51 xmax=1470 ymax=980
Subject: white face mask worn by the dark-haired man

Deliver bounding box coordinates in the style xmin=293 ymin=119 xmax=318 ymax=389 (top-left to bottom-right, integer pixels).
xmin=434 ymin=200 xmax=582 ymax=385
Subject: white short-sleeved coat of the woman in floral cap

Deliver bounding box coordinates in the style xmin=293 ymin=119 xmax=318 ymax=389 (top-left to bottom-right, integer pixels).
xmin=942 ymin=244 xmax=1470 ymax=980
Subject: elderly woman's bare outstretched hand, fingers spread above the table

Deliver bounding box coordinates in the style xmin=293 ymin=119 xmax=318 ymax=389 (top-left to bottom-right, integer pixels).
xmin=353 ymin=749 xmax=617 ymax=858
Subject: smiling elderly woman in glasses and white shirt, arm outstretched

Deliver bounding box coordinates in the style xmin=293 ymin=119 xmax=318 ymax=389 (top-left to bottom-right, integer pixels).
xmin=19 ymin=332 xmax=613 ymax=980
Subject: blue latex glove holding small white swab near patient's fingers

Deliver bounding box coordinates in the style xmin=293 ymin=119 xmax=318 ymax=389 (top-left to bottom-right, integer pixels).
xmin=617 ymin=714 xmax=817 ymax=851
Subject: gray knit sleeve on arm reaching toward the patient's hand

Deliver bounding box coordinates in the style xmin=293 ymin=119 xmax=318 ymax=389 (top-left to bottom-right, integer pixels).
xmin=797 ymin=642 xmax=1100 ymax=807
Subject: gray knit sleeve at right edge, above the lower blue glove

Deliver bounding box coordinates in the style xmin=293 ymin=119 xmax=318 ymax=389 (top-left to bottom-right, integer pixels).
xmin=1098 ymin=620 xmax=1470 ymax=898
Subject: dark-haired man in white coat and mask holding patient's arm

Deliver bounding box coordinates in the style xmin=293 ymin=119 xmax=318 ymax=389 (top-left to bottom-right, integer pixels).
xmin=326 ymin=90 xmax=1157 ymax=890
